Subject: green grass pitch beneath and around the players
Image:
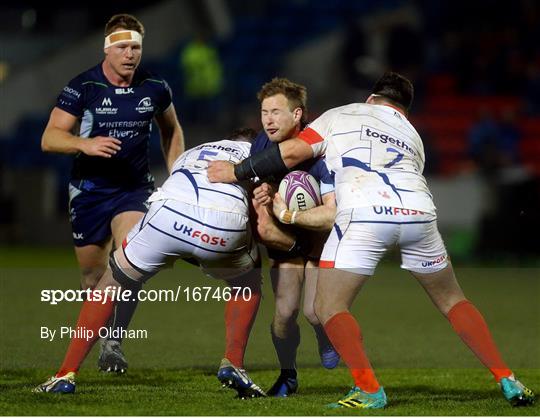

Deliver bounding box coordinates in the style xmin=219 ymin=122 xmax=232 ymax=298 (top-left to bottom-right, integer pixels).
xmin=0 ymin=249 xmax=540 ymax=415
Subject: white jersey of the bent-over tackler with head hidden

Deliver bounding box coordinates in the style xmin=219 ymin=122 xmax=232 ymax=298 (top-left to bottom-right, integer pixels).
xmin=149 ymin=140 xmax=251 ymax=216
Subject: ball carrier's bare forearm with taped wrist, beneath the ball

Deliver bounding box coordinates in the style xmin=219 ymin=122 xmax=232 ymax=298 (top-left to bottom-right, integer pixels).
xmin=273 ymin=192 xmax=336 ymax=231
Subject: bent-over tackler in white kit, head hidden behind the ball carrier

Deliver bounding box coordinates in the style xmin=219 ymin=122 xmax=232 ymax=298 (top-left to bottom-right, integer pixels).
xmin=34 ymin=130 xmax=265 ymax=398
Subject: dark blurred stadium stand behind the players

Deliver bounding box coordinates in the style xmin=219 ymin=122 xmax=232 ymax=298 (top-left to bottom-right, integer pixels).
xmin=0 ymin=0 xmax=540 ymax=263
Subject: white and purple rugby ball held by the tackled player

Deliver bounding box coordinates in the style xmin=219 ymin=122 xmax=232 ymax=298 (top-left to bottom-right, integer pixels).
xmin=279 ymin=170 xmax=321 ymax=210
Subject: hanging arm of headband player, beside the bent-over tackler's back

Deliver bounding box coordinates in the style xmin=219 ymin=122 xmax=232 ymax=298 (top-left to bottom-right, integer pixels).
xmin=156 ymin=103 xmax=185 ymax=173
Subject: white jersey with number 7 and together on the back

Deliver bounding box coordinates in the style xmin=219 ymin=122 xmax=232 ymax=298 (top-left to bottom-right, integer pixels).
xmin=299 ymin=103 xmax=435 ymax=213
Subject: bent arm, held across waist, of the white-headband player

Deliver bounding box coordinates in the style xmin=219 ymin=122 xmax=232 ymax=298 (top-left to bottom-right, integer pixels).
xmin=41 ymin=107 xmax=121 ymax=158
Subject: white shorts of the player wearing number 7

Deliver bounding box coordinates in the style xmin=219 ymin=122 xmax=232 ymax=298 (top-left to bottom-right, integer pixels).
xmin=319 ymin=206 xmax=448 ymax=276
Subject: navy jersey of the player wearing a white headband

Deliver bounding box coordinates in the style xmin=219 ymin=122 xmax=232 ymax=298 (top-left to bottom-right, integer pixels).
xmin=56 ymin=63 xmax=172 ymax=187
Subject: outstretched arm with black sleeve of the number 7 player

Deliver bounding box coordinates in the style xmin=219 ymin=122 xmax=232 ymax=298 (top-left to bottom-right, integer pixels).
xmin=208 ymin=138 xmax=313 ymax=183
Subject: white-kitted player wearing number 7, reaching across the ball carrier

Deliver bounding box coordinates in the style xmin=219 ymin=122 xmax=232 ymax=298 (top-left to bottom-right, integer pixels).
xmin=208 ymin=72 xmax=534 ymax=408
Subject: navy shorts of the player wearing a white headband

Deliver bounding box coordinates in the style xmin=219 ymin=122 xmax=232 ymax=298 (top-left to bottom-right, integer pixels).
xmin=69 ymin=180 xmax=153 ymax=247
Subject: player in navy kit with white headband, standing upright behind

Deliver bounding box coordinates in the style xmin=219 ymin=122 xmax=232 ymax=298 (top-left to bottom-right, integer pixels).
xmin=41 ymin=14 xmax=184 ymax=372
